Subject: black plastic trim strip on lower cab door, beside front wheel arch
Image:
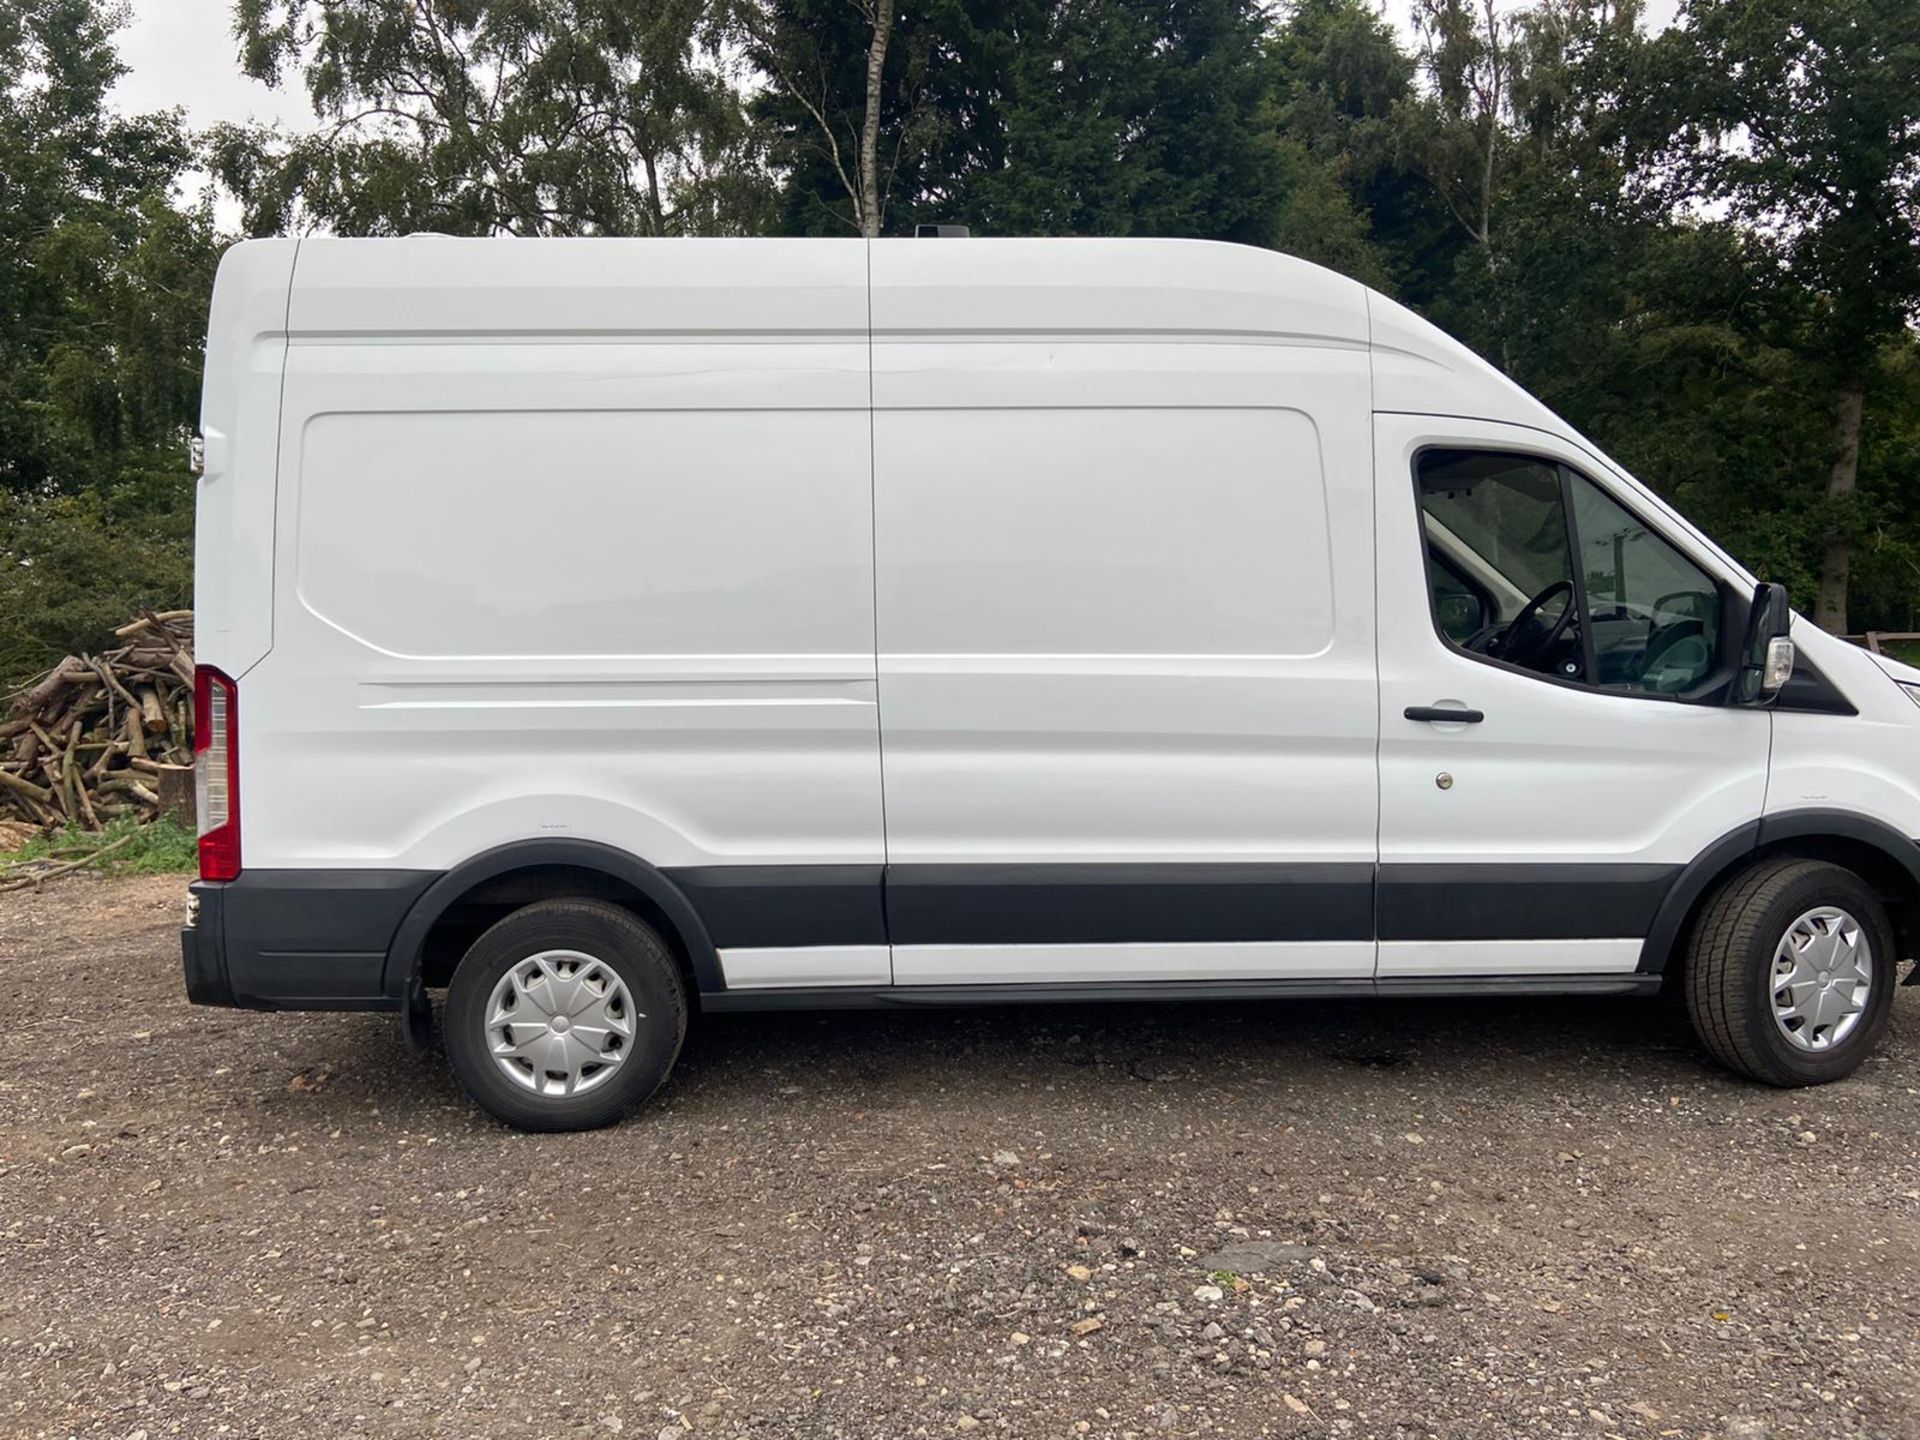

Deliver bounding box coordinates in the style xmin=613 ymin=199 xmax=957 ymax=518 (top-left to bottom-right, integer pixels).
xmin=1377 ymin=864 xmax=1682 ymax=941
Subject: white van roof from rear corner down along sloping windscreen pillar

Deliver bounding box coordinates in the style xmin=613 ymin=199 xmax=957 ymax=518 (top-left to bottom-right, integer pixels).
xmin=215 ymin=236 xmax=1758 ymax=587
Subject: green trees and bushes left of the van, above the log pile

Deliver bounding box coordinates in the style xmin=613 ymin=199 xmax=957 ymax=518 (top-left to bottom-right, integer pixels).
xmin=0 ymin=0 xmax=217 ymax=678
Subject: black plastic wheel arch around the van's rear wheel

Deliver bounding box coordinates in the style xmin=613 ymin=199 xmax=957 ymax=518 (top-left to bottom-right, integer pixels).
xmin=384 ymin=839 xmax=724 ymax=995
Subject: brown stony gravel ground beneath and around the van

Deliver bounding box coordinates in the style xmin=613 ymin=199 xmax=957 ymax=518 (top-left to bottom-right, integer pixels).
xmin=0 ymin=879 xmax=1920 ymax=1440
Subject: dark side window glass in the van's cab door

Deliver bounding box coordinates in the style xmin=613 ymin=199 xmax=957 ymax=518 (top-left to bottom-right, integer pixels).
xmin=1417 ymin=449 xmax=1720 ymax=695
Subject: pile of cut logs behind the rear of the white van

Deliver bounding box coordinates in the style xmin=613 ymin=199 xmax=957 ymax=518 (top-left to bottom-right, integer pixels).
xmin=0 ymin=611 xmax=194 ymax=829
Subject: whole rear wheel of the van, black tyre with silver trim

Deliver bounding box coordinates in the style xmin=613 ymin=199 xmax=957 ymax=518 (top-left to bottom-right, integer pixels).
xmin=442 ymin=900 xmax=687 ymax=1131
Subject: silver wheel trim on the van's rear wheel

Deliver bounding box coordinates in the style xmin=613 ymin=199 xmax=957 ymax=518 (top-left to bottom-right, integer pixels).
xmin=486 ymin=950 xmax=645 ymax=1100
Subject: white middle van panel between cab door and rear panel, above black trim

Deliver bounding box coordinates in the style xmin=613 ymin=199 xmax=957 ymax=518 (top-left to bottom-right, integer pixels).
xmin=874 ymin=240 xmax=1375 ymax=864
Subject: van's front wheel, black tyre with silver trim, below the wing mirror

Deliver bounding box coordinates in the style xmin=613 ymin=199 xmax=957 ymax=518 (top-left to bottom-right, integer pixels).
xmin=1686 ymin=860 xmax=1897 ymax=1085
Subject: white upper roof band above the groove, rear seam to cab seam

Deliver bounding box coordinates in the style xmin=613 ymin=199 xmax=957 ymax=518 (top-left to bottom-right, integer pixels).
xmin=290 ymin=236 xmax=1367 ymax=346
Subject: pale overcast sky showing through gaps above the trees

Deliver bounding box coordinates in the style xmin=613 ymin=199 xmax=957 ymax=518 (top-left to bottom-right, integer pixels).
xmin=115 ymin=0 xmax=1678 ymax=129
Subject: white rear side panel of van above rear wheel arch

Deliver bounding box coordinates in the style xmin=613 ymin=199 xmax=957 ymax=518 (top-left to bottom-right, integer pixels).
xmin=242 ymin=238 xmax=881 ymax=870
